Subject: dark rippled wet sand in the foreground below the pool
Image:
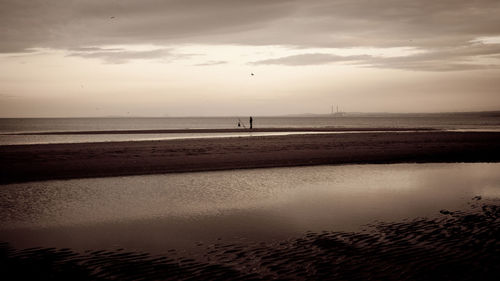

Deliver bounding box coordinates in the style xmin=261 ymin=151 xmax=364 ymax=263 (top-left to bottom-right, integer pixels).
xmin=0 ymin=197 xmax=500 ymax=281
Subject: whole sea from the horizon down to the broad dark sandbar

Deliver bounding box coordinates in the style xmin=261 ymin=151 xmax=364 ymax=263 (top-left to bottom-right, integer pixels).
xmin=0 ymin=112 xmax=500 ymax=145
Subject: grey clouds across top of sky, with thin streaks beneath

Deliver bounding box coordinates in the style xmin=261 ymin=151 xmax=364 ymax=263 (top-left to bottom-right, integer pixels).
xmin=0 ymin=0 xmax=500 ymax=68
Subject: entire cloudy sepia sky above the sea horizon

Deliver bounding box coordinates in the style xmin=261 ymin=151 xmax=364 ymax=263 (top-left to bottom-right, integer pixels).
xmin=0 ymin=0 xmax=500 ymax=117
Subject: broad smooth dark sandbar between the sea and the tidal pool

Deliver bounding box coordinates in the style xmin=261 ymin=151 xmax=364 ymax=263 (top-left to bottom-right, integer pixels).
xmin=0 ymin=128 xmax=500 ymax=184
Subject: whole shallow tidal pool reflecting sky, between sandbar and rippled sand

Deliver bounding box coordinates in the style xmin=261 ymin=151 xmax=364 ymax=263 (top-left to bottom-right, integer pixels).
xmin=0 ymin=163 xmax=500 ymax=250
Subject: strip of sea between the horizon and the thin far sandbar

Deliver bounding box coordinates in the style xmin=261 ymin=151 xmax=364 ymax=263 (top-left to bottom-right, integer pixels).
xmin=0 ymin=114 xmax=500 ymax=133
